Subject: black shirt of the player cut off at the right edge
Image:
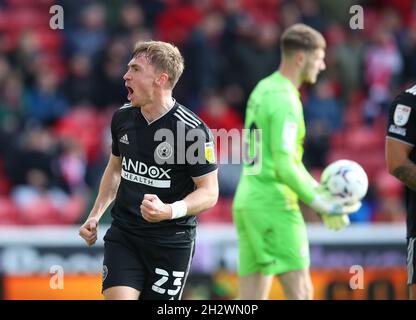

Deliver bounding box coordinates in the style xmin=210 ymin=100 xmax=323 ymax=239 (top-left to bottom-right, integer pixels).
xmin=387 ymin=86 xmax=416 ymax=237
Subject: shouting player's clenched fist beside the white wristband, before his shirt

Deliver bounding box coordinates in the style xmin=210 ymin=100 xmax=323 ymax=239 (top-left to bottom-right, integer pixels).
xmin=140 ymin=194 xmax=172 ymax=222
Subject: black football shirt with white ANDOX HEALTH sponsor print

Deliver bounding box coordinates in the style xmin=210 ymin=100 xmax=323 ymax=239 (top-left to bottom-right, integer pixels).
xmin=111 ymin=101 xmax=217 ymax=244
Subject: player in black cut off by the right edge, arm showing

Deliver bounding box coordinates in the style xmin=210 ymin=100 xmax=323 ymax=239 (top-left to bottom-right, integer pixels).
xmin=386 ymin=86 xmax=416 ymax=300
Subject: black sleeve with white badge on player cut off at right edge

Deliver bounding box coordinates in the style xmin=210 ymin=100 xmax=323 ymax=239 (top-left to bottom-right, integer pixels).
xmin=387 ymin=93 xmax=416 ymax=145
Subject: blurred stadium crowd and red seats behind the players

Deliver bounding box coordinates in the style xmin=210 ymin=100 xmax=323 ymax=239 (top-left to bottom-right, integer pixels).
xmin=0 ymin=0 xmax=416 ymax=225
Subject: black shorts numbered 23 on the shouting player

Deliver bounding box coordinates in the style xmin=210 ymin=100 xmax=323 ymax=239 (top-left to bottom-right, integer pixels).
xmin=103 ymin=225 xmax=195 ymax=300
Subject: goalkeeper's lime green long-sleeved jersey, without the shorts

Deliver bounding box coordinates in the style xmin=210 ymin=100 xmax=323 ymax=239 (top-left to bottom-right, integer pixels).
xmin=234 ymin=72 xmax=317 ymax=211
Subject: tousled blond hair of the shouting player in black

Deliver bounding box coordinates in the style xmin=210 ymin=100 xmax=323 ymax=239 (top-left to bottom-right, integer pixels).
xmin=132 ymin=41 xmax=184 ymax=88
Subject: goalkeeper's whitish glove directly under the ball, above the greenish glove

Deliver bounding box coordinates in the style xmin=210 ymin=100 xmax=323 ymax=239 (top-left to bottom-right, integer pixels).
xmin=309 ymin=192 xmax=361 ymax=215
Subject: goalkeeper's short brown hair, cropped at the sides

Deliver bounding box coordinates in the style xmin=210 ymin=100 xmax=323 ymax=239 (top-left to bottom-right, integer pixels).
xmin=280 ymin=23 xmax=326 ymax=56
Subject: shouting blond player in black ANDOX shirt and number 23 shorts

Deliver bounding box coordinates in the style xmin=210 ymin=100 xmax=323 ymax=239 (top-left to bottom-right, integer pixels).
xmin=79 ymin=41 xmax=218 ymax=300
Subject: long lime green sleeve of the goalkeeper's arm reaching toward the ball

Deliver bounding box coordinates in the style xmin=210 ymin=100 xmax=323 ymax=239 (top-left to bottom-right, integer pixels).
xmin=270 ymin=97 xmax=316 ymax=204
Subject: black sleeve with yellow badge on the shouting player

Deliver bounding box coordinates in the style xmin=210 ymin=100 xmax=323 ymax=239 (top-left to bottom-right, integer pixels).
xmin=186 ymin=125 xmax=217 ymax=178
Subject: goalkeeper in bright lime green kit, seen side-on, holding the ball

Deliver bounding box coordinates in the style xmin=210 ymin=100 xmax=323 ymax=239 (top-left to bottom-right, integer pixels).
xmin=233 ymin=24 xmax=361 ymax=299
